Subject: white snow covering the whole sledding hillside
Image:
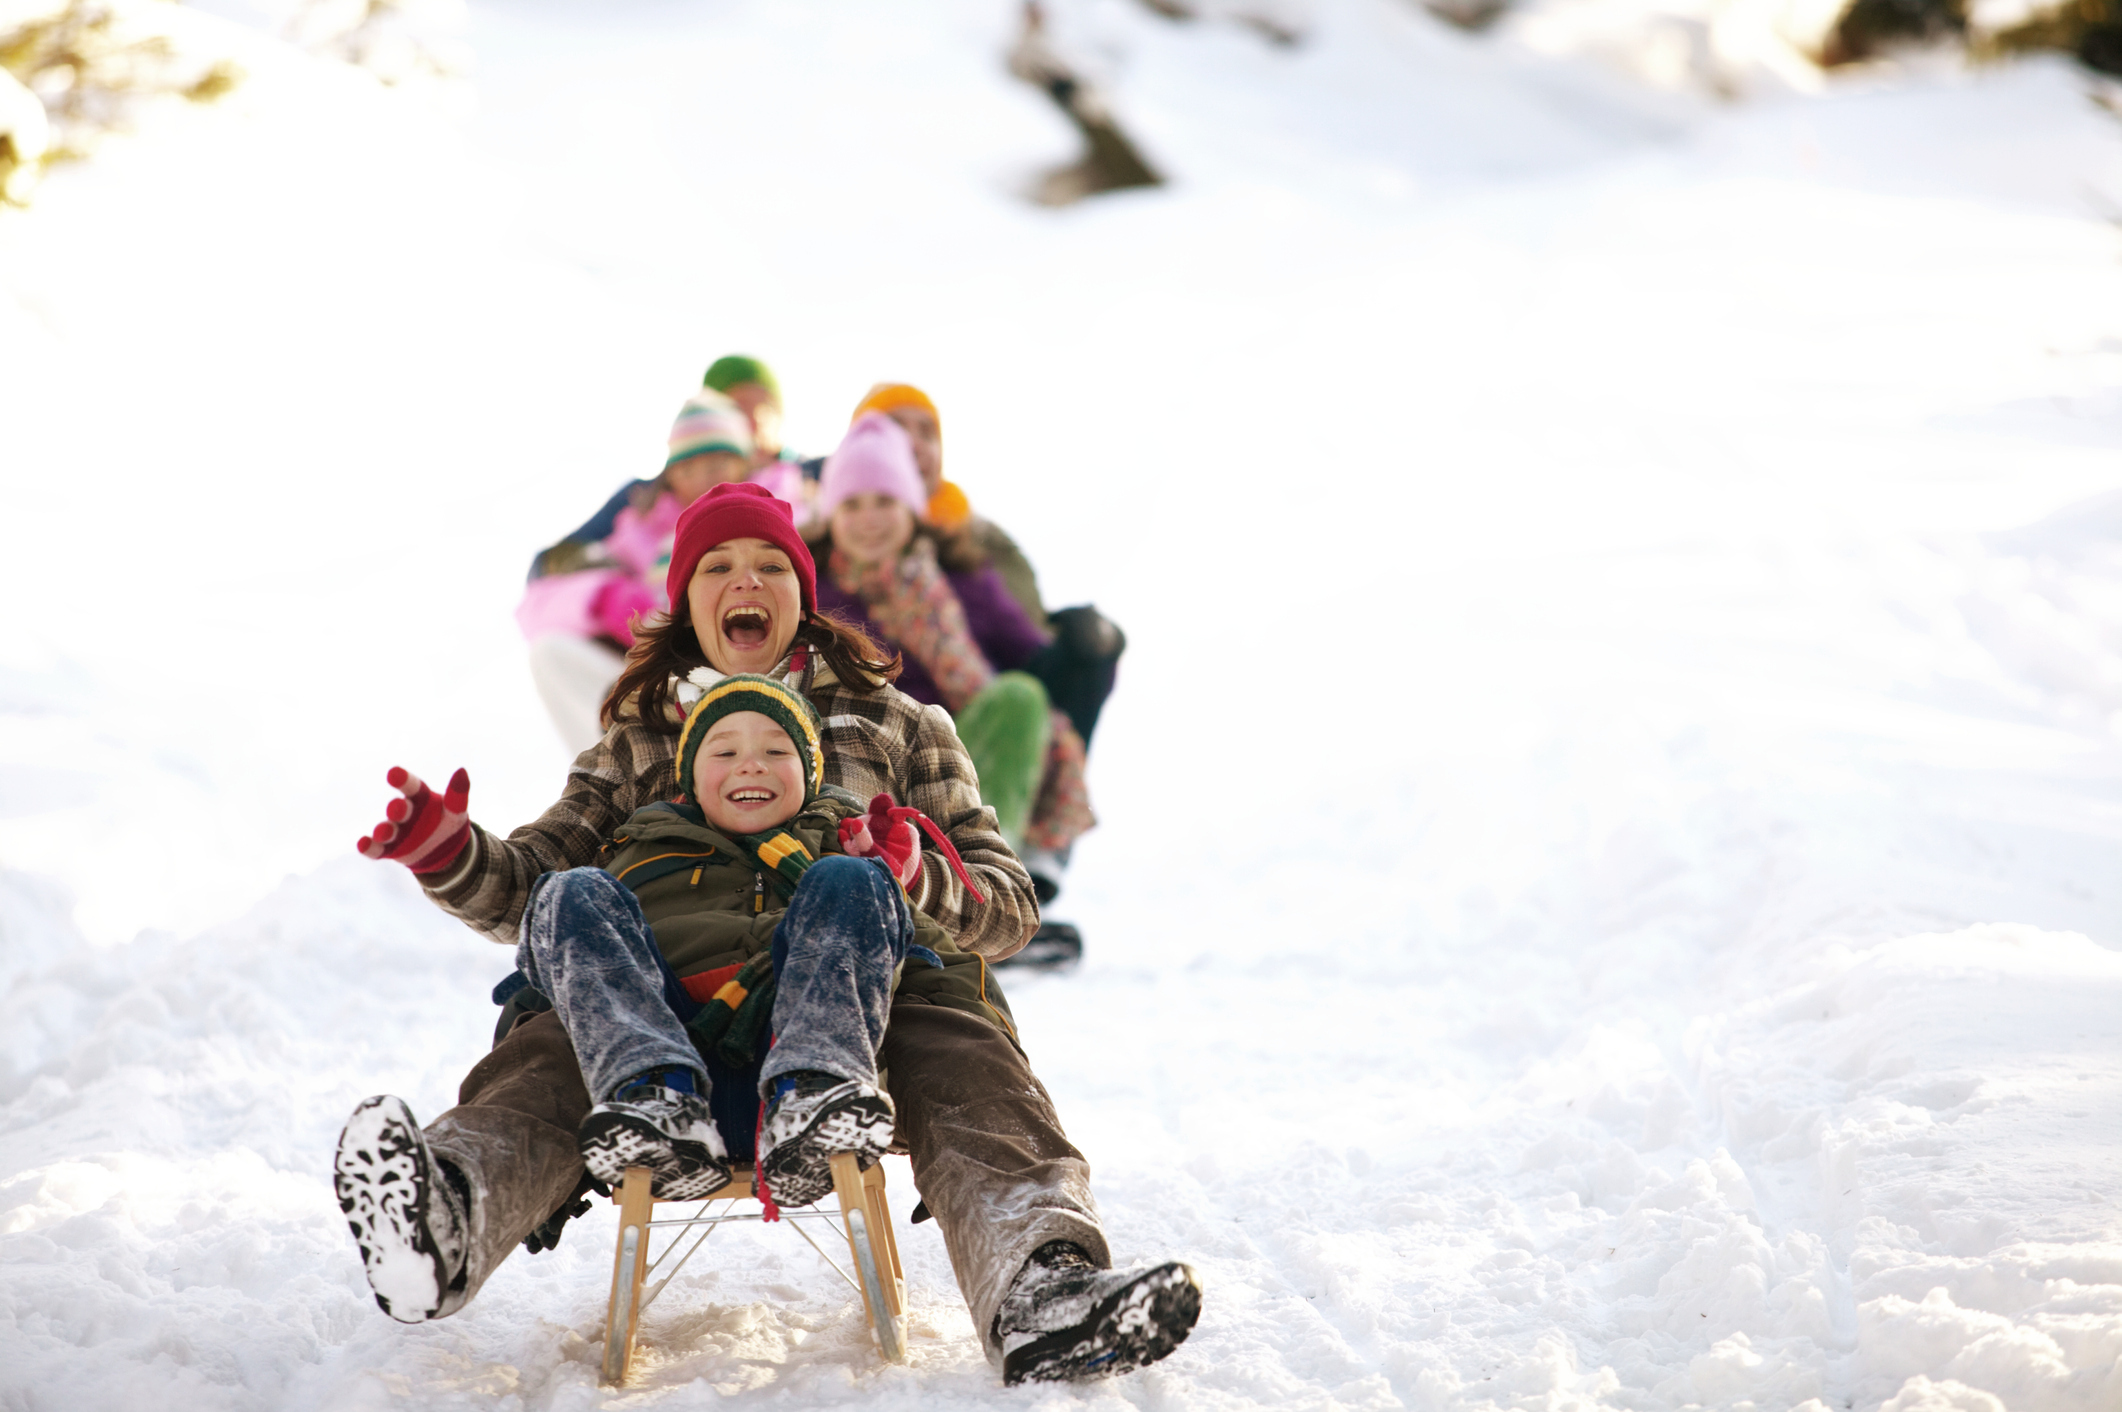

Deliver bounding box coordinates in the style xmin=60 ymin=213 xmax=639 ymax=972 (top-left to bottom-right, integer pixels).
xmin=0 ymin=0 xmax=2122 ymax=1412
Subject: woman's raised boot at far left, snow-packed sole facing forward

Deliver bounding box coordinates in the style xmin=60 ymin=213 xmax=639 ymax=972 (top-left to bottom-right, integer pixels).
xmin=331 ymin=1094 xmax=471 ymax=1323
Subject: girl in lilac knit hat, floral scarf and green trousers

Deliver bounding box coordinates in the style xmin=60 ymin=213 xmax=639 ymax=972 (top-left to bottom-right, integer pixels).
xmin=811 ymin=412 xmax=1095 ymax=900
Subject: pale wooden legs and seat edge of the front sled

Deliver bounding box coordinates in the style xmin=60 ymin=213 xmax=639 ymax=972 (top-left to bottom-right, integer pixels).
xmin=603 ymin=1155 xmax=906 ymax=1387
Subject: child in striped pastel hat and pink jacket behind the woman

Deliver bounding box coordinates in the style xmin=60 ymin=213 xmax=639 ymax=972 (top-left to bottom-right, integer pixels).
xmin=516 ymin=389 xmax=755 ymax=754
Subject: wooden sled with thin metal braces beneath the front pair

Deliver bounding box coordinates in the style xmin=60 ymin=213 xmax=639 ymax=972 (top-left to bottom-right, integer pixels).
xmin=603 ymin=1153 xmax=906 ymax=1387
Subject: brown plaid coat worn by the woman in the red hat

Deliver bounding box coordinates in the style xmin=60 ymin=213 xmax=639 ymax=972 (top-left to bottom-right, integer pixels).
xmin=420 ymin=654 xmax=1040 ymax=960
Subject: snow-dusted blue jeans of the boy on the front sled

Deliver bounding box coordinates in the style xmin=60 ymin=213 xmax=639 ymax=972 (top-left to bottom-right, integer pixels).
xmin=516 ymin=856 xmax=915 ymax=1138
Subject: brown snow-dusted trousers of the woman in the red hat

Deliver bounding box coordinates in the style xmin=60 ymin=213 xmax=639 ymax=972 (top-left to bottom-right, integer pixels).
xmin=427 ymin=996 xmax=1112 ymax=1359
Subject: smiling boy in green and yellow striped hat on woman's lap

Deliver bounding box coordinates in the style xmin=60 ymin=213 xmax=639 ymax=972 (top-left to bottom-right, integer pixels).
xmin=547 ymin=675 xmax=970 ymax=1206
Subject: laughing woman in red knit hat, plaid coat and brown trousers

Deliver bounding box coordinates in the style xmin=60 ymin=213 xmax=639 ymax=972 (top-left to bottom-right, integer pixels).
xmin=340 ymin=484 xmax=1199 ymax=1382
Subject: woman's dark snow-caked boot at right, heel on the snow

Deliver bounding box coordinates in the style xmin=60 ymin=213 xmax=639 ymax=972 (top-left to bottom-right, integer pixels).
xmin=995 ymin=1240 xmax=1201 ymax=1387
